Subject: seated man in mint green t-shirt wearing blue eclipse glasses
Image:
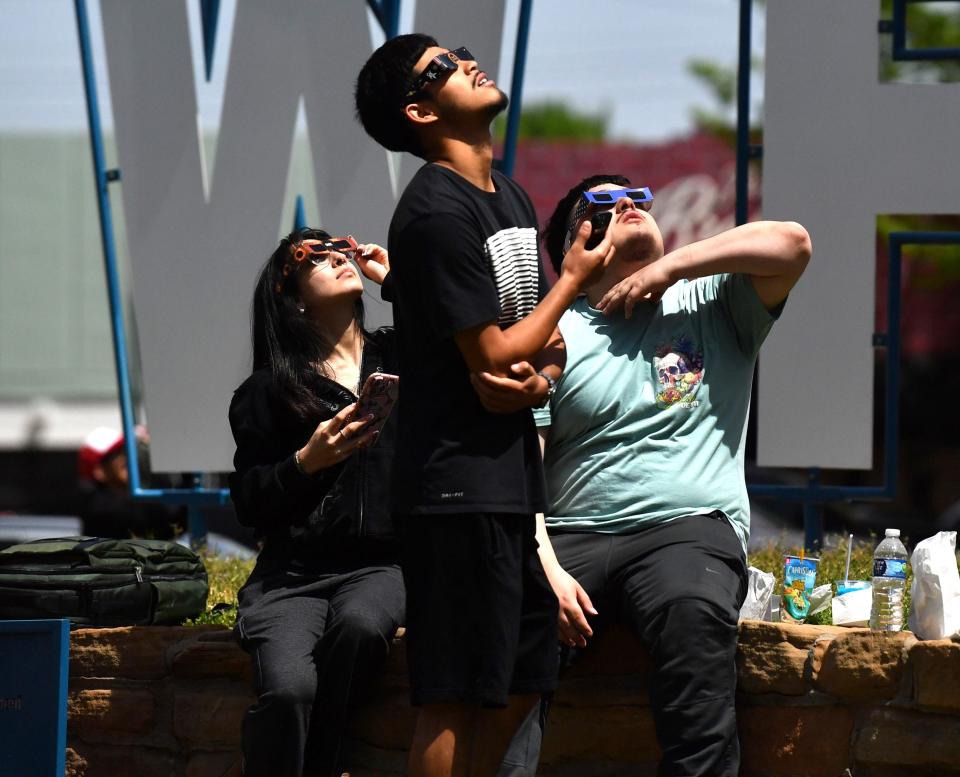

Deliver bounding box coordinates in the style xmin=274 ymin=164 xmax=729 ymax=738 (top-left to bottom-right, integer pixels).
xmin=482 ymin=175 xmax=811 ymax=777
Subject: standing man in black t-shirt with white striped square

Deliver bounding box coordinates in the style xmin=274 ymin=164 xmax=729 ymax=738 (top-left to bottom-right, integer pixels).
xmin=356 ymin=35 xmax=612 ymax=775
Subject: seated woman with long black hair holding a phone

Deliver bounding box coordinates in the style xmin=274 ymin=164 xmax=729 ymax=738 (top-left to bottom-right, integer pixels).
xmin=230 ymin=229 xmax=404 ymax=777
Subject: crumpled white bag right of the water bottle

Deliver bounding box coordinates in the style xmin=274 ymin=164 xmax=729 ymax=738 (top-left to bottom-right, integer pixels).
xmin=909 ymin=531 xmax=960 ymax=639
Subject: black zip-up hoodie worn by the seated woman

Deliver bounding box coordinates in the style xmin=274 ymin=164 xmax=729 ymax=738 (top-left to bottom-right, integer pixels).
xmin=230 ymin=327 xmax=397 ymax=559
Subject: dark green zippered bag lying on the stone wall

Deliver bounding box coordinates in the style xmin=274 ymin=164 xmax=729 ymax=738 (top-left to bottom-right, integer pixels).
xmin=0 ymin=537 xmax=209 ymax=626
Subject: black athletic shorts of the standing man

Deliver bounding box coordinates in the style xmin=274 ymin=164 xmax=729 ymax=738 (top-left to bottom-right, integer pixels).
xmin=398 ymin=513 xmax=558 ymax=707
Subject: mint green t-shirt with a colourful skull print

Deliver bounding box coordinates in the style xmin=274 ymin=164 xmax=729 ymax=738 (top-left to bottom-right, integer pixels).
xmin=535 ymin=275 xmax=782 ymax=547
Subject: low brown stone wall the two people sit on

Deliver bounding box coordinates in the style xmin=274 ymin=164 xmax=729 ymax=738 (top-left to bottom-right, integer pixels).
xmin=67 ymin=621 xmax=960 ymax=777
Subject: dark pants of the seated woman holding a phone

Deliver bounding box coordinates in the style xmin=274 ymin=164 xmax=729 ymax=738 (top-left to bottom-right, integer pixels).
xmin=236 ymin=565 xmax=404 ymax=777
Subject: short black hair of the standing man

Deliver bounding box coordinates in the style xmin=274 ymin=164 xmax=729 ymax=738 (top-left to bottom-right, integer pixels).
xmin=353 ymin=33 xmax=437 ymax=157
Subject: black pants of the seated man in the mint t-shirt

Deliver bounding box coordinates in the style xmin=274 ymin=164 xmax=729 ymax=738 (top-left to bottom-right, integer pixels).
xmin=499 ymin=513 xmax=747 ymax=777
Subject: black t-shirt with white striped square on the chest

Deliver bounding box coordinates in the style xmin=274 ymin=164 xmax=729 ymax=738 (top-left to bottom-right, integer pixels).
xmin=389 ymin=164 xmax=546 ymax=514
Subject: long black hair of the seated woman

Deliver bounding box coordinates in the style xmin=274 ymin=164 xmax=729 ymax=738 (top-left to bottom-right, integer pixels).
xmin=252 ymin=229 xmax=363 ymax=419
